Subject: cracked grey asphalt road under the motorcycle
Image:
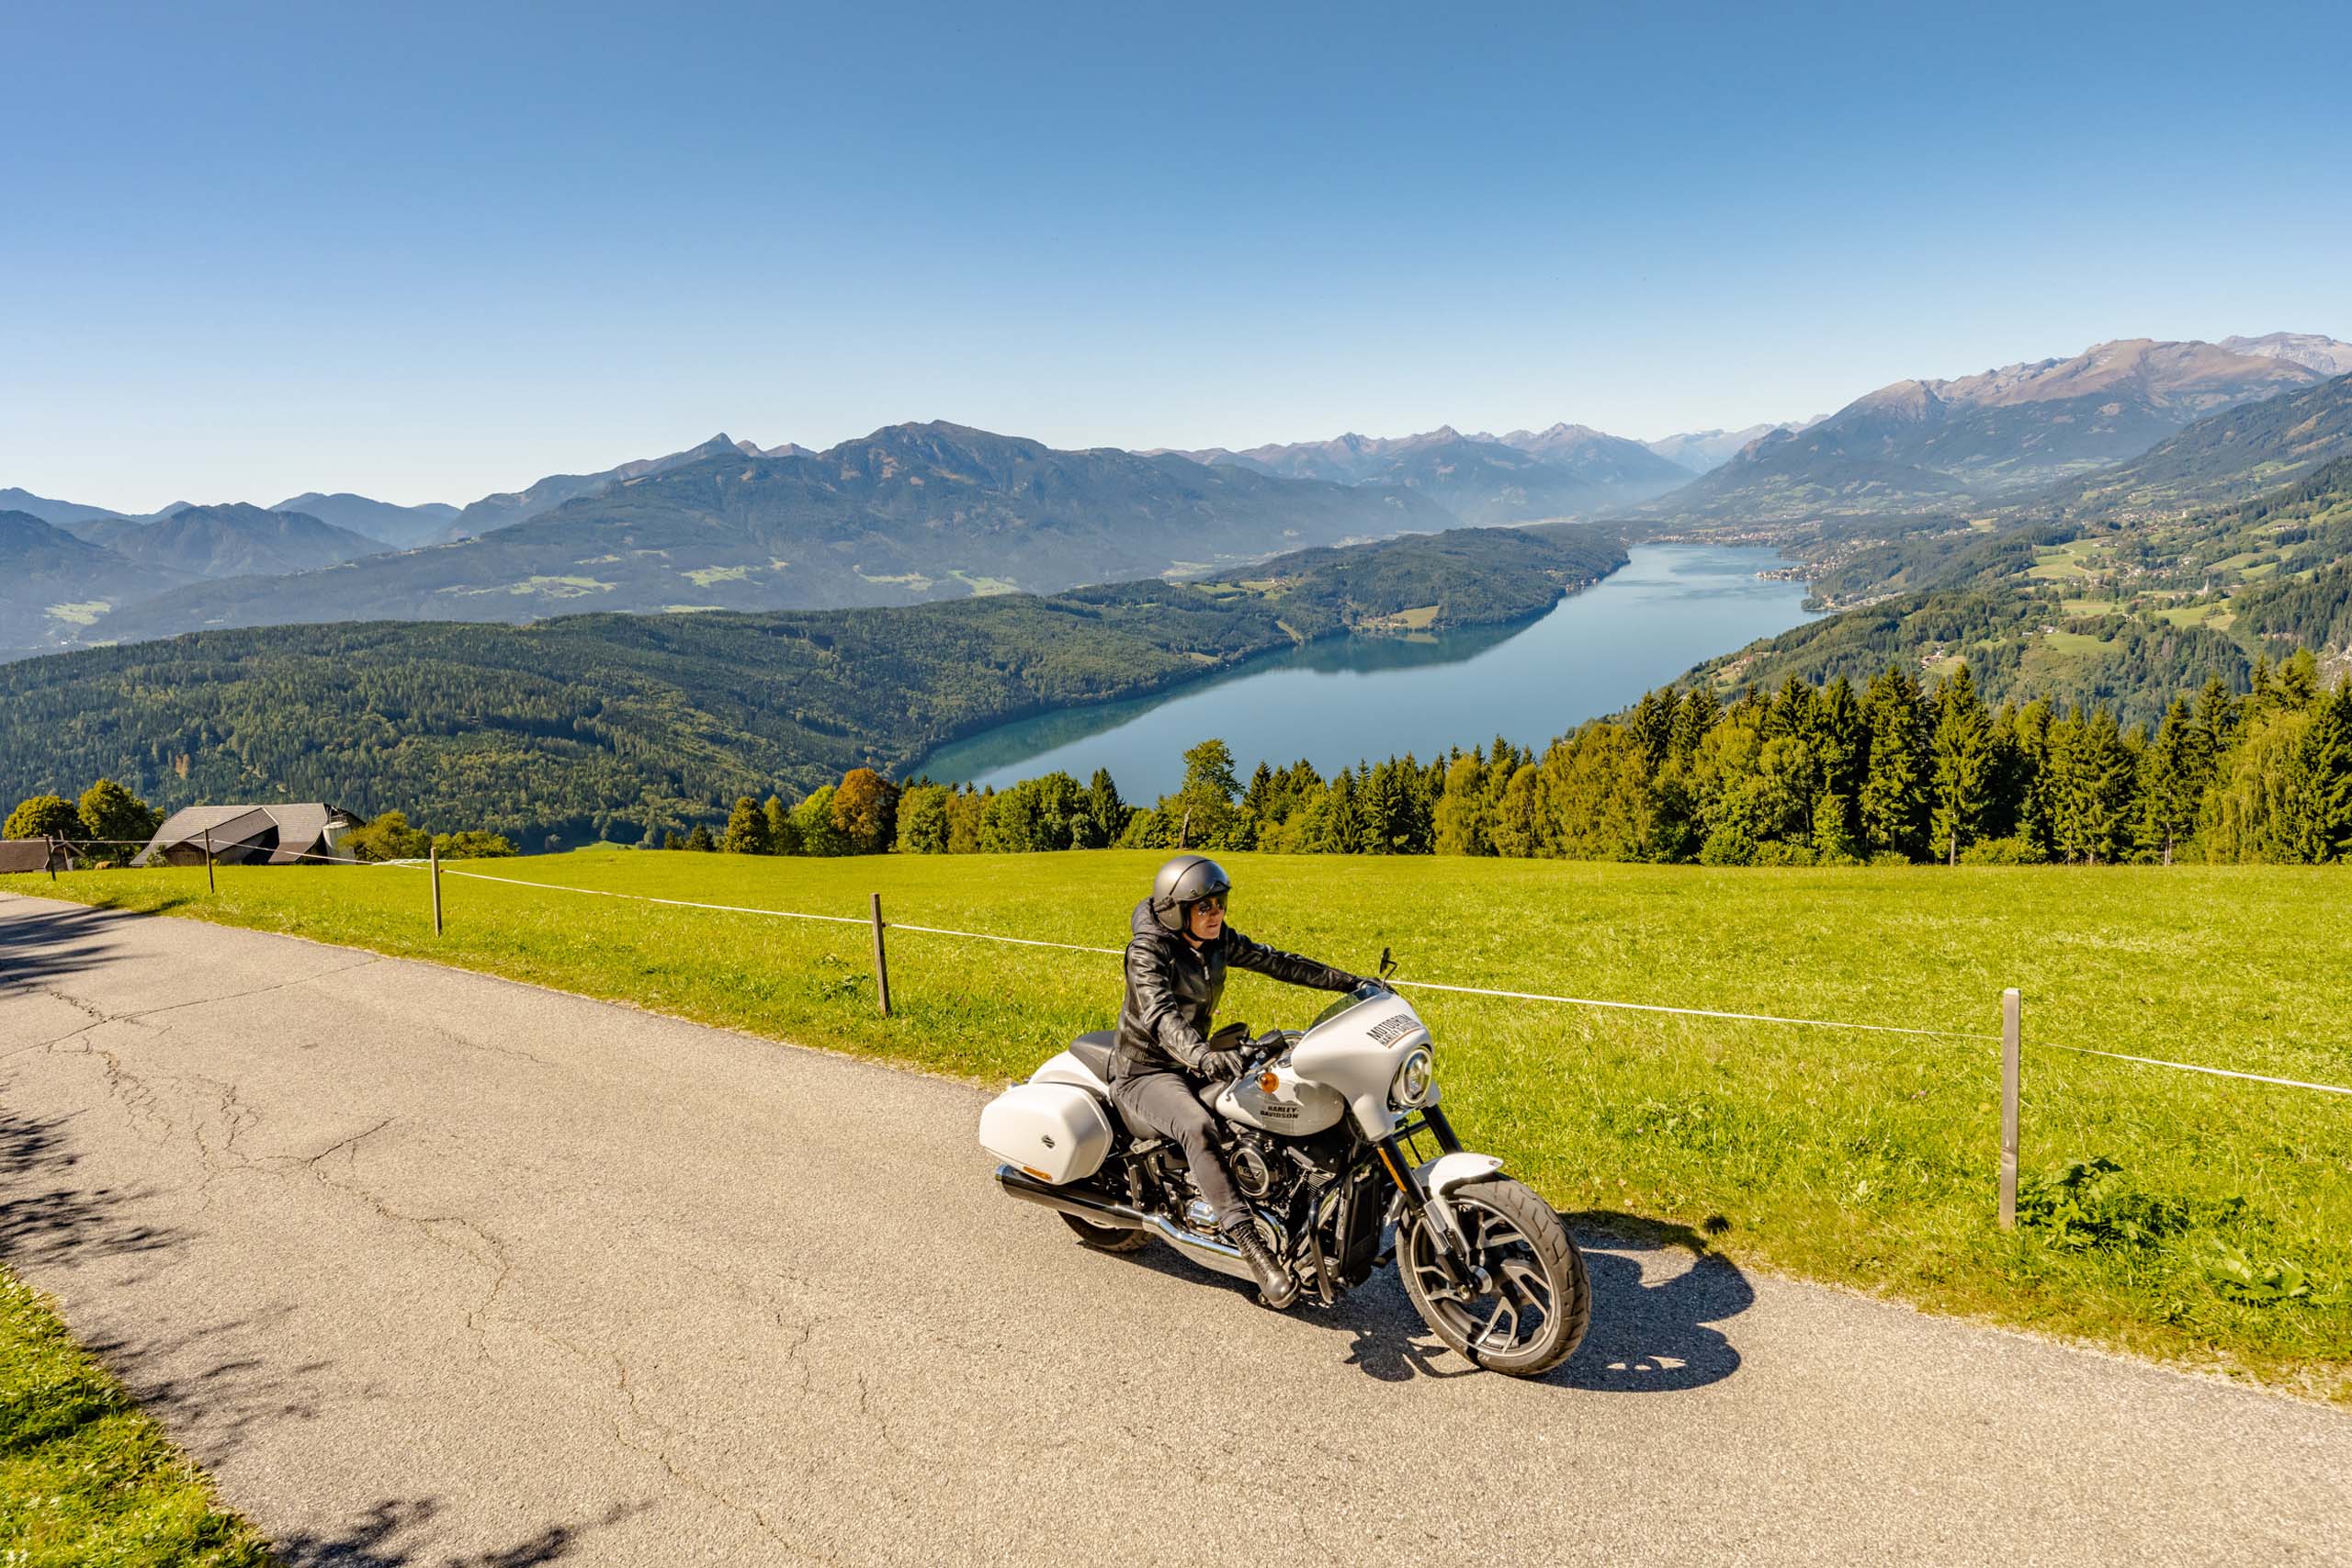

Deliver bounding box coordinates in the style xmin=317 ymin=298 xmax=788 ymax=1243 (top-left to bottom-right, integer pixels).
xmin=0 ymin=896 xmax=2352 ymax=1568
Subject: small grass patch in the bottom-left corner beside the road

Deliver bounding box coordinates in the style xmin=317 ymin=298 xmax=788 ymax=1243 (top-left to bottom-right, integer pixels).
xmin=0 ymin=1269 xmax=276 ymax=1568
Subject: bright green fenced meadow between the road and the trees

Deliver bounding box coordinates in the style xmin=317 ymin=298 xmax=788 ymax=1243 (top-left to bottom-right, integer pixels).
xmin=0 ymin=849 xmax=2352 ymax=1404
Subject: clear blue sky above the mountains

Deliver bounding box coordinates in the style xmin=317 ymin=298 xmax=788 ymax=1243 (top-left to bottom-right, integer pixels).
xmin=0 ymin=3 xmax=2352 ymax=510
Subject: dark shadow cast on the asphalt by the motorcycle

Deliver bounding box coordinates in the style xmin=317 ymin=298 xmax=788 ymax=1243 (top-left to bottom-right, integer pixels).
xmin=1114 ymin=1208 xmax=1755 ymax=1394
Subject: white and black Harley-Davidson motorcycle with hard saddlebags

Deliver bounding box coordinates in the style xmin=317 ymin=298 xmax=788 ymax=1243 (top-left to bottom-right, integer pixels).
xmin=981 ymin=973 xmax=1592 ymax=1378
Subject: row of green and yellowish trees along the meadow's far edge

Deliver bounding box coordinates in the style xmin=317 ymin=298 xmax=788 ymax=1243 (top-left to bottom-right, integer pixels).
xmin=879 ymin=653 xmax=2352 ymax=865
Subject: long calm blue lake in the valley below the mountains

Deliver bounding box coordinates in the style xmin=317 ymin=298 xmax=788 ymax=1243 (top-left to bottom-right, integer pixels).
xmin=910 ymin=546 xmax=1814 ymax=802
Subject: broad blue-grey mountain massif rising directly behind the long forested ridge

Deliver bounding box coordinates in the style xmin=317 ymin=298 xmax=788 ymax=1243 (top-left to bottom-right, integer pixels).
xmin=41 ymin=423 xmax=1456 ymax=639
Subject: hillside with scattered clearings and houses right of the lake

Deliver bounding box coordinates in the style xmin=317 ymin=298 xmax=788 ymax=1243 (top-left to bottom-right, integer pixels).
xmin=1674 ymin=376 xmax=2352 ymax=724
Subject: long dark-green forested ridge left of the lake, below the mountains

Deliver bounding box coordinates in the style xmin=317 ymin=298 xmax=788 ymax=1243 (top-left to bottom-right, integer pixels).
xmin=0 ymin=529 xmax=1625 ymax=846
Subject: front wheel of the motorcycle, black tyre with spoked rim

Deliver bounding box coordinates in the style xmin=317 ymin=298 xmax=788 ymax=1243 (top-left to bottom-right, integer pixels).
xmin=1397 ymin=1178 xmax=1592 ymax=1378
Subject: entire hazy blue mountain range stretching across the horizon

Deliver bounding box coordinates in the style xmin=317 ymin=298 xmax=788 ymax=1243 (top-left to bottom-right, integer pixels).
xmin=0 ymin=332 xmax=2352 ymax=677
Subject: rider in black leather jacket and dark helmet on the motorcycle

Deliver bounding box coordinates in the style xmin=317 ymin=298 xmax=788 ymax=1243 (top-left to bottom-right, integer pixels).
xmin=1110 ymin=856 xmax=1362 ymax=1307
